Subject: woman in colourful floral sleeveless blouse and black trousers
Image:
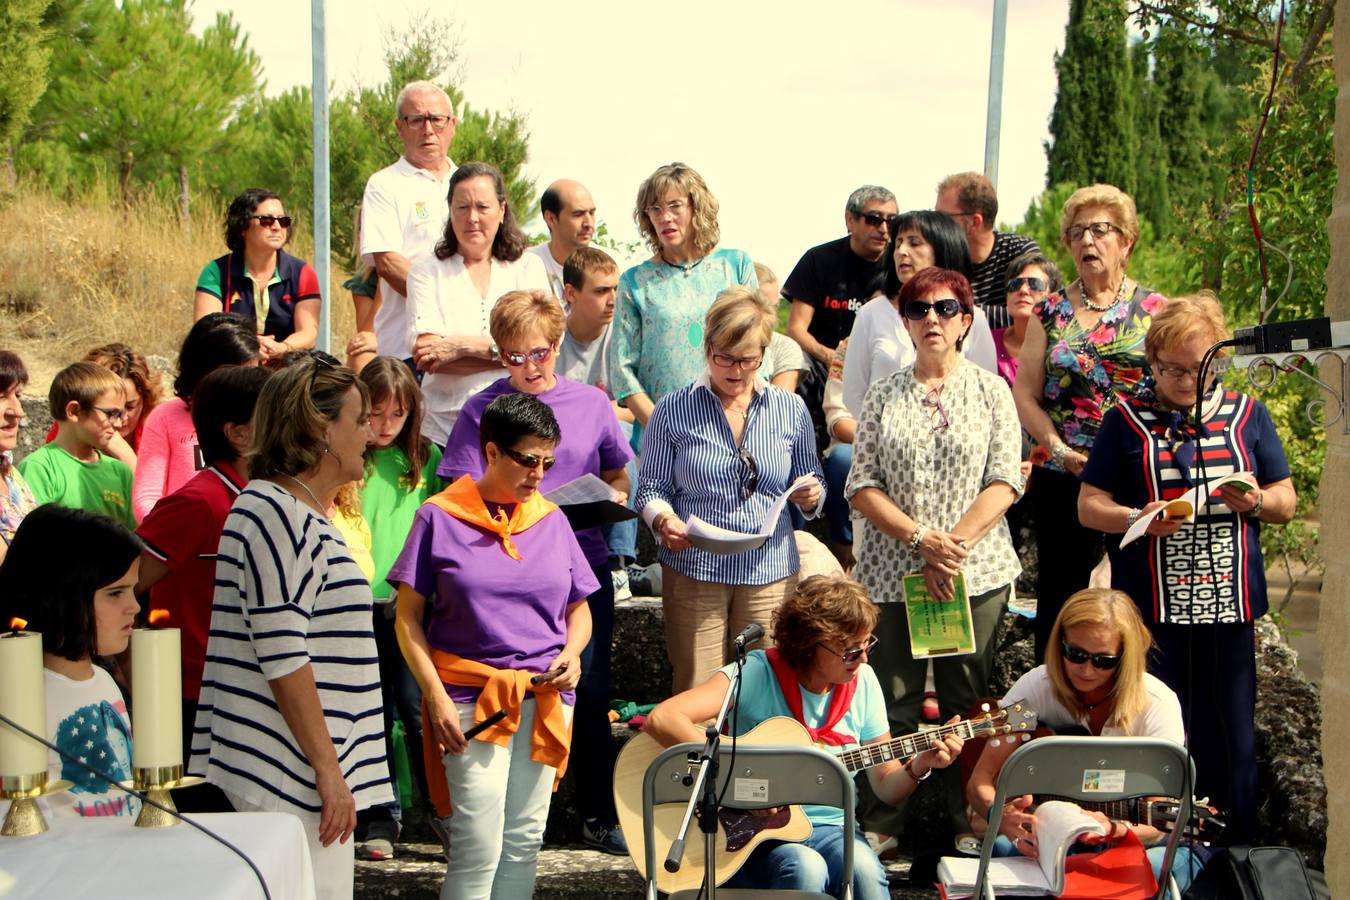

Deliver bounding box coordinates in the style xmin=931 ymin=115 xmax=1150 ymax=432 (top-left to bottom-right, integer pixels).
xmin=1013 ymin=185 xmax=1166 ymax=663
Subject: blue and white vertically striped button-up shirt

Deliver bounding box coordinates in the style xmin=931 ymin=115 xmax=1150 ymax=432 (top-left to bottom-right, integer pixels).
xmin=633 ymin=371 xmax=825 ymax=584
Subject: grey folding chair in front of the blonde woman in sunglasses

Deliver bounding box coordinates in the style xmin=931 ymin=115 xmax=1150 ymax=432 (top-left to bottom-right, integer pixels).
xmin=975 ymin=737 xmax=1195 ymax=900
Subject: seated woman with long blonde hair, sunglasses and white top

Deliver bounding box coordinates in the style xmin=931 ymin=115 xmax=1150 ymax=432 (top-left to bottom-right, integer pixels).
xmin=965 ymin=587 xmax=1200 ymax=892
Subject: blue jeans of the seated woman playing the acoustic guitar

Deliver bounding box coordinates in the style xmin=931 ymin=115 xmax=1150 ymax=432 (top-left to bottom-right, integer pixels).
xmin=723 ymin=824 xmax=891 ymax=900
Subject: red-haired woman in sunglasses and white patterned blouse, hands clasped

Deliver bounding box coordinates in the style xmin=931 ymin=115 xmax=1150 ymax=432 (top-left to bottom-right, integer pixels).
xmin=845 ymin=269 xmax=1022 ymax=839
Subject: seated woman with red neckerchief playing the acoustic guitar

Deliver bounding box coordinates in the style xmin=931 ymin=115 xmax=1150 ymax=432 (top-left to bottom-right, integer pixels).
xmin=647 ymin=575 xmax=961 ymax=900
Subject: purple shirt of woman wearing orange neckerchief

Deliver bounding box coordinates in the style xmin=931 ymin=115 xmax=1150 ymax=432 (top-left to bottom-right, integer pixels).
xmin=389 ymin=503 xmax=599 ymax=703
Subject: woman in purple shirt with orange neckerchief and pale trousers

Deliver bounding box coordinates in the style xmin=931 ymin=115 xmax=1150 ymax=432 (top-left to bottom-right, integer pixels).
xmin=389 ymin=394 xmax=599 ymax=900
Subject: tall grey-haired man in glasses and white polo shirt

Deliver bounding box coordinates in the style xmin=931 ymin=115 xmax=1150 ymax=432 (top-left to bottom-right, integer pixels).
xmin=360 ymin=81 xmax=456 ymax=359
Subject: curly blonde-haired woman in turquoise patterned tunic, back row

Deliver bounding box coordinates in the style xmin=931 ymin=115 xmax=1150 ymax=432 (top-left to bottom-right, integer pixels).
xmin=609 ymin=162 xmax=763 ymax=447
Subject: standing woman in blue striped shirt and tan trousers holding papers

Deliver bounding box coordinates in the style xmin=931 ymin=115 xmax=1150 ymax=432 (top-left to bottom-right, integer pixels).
xmin=633 ymin=287 xmax=825 ymax=692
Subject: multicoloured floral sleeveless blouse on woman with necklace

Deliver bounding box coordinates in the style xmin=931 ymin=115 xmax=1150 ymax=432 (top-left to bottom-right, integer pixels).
xmin=1031 ymin=286 xmax=1168 ymax=471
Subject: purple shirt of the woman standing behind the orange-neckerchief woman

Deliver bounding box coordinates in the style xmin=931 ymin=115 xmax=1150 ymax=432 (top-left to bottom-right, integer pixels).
xmin=436 ymin=375 xmax=633 ymax=567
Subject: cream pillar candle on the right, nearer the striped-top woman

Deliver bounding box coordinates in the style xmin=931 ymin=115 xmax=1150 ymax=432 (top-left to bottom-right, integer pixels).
xmin=131 ymin=629 xmax=182 ymax=769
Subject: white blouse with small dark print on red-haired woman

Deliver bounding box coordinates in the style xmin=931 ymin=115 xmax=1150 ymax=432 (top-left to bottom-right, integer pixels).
xmin=844 ymin=363 xmax=1022 ymax=603
